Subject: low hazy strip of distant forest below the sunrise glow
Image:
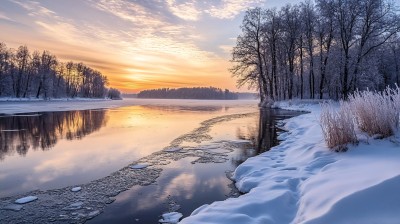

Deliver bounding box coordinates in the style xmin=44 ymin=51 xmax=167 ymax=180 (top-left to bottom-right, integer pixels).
xmin=137 ymin=87 xmax=238 ymax=100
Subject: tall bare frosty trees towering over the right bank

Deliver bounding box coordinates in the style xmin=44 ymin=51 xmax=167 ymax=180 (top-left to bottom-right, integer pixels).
xmin=231 ymin=0 xmax=400 ymax=102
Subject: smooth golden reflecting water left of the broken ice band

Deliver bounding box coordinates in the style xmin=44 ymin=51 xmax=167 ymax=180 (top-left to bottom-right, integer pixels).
xmin=0 ymin=101 xmax=256 ymax=197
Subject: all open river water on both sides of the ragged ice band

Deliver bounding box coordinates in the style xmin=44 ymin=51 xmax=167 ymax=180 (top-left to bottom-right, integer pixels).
xmin=0 ymin=102 xmax=300 ymax=223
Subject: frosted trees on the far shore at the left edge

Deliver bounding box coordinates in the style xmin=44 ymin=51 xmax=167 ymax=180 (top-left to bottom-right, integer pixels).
xmin=0 ymin=43 xmax=120 ymax=99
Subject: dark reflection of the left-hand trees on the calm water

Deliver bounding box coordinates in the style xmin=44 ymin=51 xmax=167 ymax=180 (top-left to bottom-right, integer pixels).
xmin=0 ymin=110 xmax=108 ymax=160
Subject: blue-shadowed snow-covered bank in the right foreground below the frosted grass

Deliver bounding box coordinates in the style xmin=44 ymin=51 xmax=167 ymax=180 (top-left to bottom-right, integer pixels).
xmin=180 ymin=103 xmax=400 ymax=224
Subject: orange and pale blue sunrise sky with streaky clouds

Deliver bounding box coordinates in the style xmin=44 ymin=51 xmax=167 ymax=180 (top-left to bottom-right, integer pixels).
xmin=0 ymin=0 xmax=396 ymax=93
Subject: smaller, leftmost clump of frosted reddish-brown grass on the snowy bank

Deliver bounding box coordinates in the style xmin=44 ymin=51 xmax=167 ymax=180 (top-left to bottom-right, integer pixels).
xmin=320 ymin=101 xmax=358 ymax=151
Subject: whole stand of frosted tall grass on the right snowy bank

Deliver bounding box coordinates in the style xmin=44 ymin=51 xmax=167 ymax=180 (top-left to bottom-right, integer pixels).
xmin=320 ymin=86 xmax=400 ymax=151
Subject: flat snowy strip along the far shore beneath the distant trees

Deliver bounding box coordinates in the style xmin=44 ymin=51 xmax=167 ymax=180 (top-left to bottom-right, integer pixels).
xmin=0 ymin=98 xmax=257 ymax=114
